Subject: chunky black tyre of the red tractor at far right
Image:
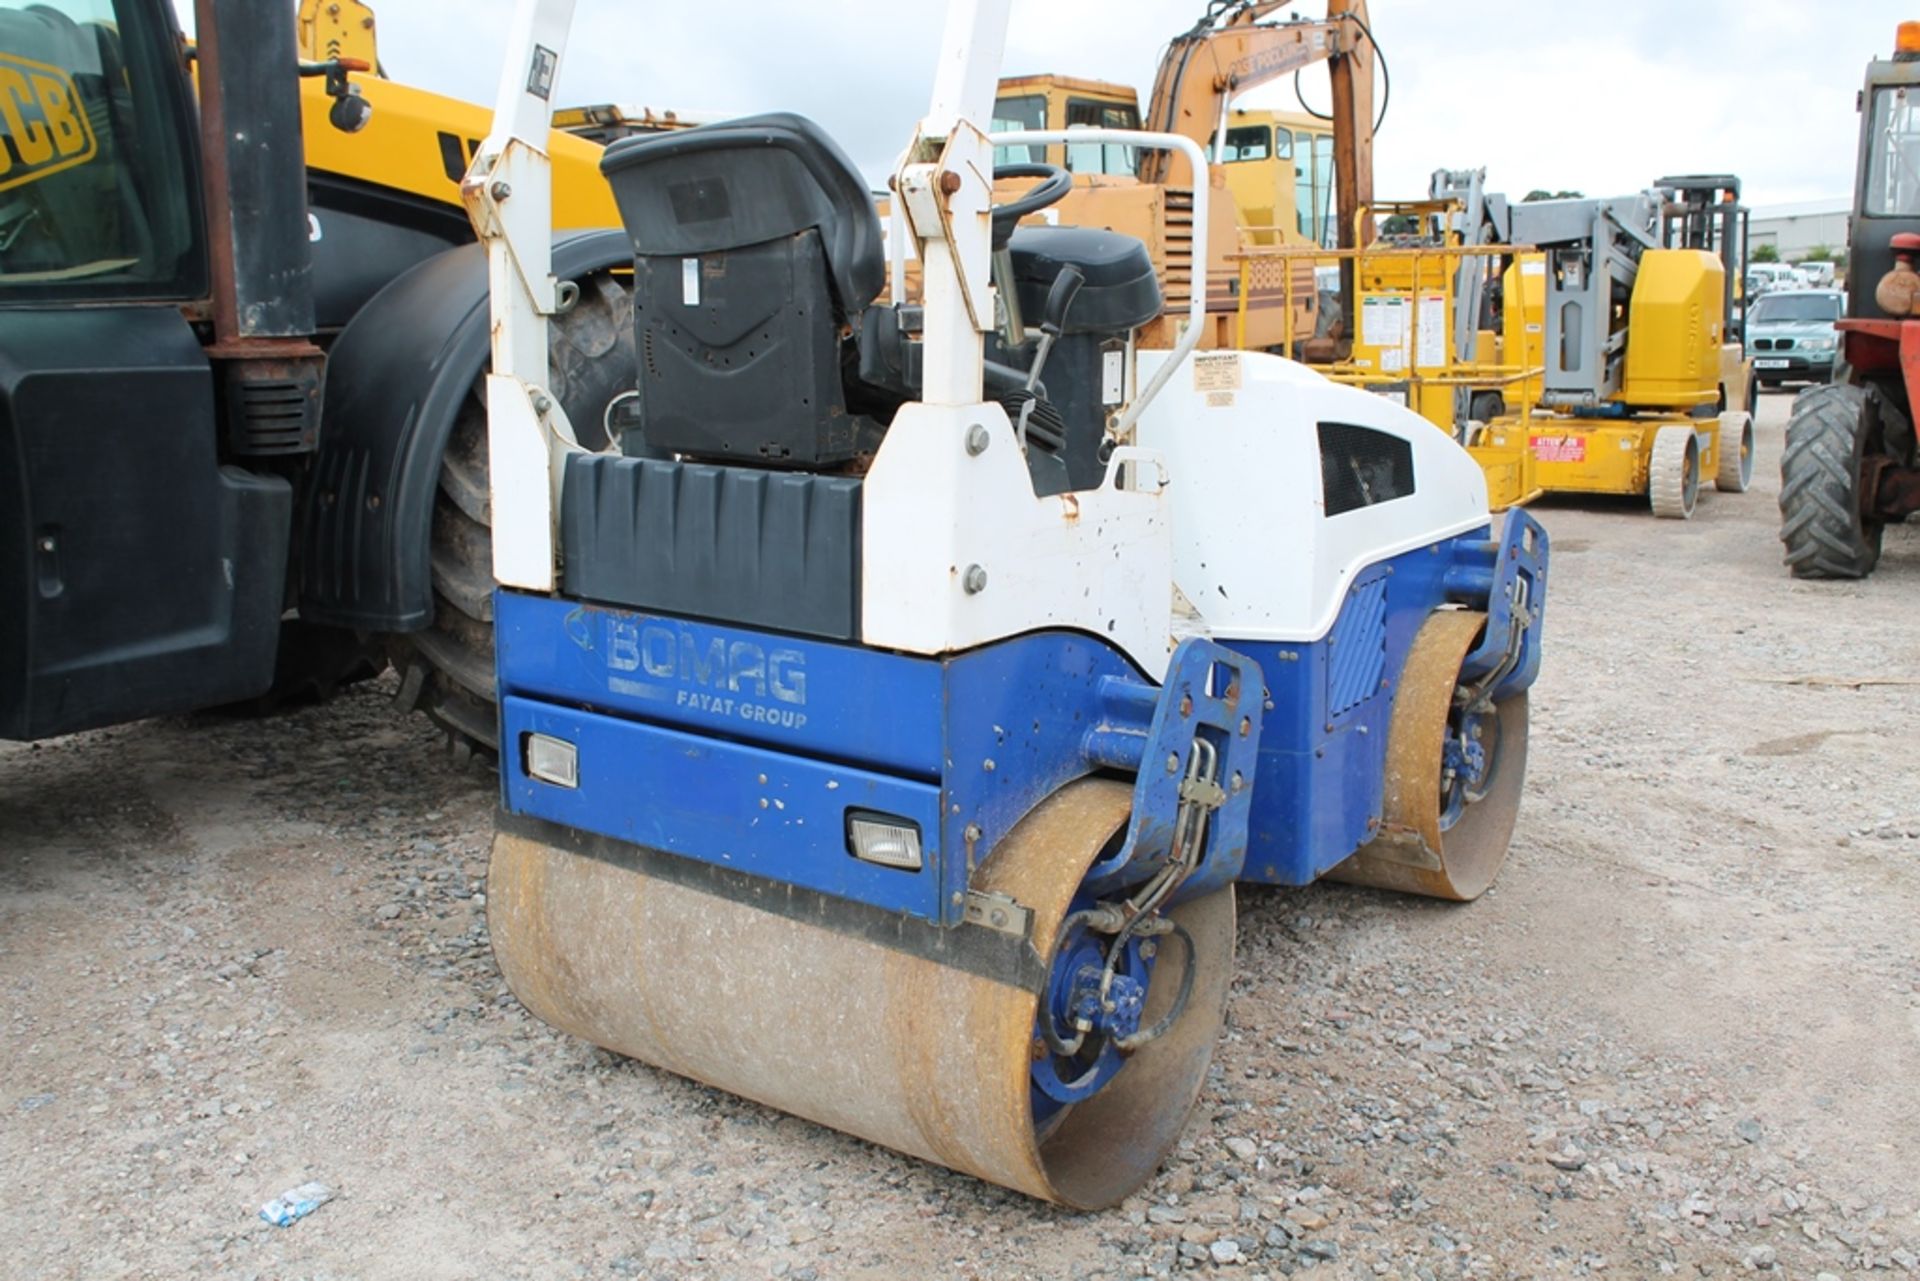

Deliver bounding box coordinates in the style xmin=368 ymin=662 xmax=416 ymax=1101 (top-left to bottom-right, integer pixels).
xmin=1780 ymin=384 xmax=1882 ymax=578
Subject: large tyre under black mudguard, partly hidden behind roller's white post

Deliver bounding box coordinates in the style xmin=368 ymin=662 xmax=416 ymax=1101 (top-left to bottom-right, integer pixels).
xmin=388 ymin=273 xmax=639 ymax=761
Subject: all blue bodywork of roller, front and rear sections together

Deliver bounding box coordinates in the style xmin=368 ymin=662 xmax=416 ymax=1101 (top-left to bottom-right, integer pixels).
xmin=495 ymin=517 xmax=1546 ymax=926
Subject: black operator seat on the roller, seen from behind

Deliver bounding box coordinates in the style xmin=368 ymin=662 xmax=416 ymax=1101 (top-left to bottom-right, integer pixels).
xmin=601 ymin=111 xmax=887 ymax=467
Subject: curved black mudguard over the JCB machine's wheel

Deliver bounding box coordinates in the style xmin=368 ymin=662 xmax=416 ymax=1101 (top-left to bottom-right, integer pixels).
xmin=296 ymin=230 xmax=634 ymax=632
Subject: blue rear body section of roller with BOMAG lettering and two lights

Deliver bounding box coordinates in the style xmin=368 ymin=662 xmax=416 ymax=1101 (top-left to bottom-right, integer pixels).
xmin=495 ymin=592 xmax=1260 ymax=924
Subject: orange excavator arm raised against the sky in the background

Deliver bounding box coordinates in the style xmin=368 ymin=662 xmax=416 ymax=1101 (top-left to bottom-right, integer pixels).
xmin=1142 ymin=0 xmax=1375 ymax=248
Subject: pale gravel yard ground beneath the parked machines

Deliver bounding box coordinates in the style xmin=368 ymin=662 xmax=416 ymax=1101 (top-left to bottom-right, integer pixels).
xmin=0 ymin=396 xmax=1920 ymax=1281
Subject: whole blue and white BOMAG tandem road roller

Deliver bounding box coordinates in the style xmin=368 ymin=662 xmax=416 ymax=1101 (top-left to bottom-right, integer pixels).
xmin=463 ymin=0 xmax=1548 ymax=1208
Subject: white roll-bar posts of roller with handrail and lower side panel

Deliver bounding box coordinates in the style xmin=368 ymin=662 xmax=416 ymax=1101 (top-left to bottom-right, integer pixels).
xmin=476 ymin=0 xmax=1210 ymax=676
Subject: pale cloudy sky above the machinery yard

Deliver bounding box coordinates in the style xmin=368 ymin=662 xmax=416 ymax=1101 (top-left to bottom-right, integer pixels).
xmin=177 ymin=0 xmax=1920 ymax=205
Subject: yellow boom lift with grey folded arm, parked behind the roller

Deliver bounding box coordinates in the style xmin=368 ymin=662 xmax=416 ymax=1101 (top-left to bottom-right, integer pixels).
xmin=1236 ymin=169 xmax=1753 ymax=519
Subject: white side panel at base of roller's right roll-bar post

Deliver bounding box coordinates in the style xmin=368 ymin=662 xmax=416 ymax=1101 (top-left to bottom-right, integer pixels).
xmin=860 ymin=403 xmax=1173 ymax=680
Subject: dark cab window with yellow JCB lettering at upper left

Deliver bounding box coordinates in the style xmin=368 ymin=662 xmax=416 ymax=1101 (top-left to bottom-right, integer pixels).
xmin=0 ymin=0 xmax=205 ymax=303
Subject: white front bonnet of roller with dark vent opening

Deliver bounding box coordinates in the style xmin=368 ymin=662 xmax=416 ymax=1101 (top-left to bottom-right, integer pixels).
xmin=1139 ymin=351 xmax=1488 ymax=641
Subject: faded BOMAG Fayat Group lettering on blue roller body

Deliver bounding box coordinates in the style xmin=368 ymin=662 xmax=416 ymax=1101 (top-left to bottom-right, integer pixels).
xmin=607 ymin=620 xmax=806 ymax=730
